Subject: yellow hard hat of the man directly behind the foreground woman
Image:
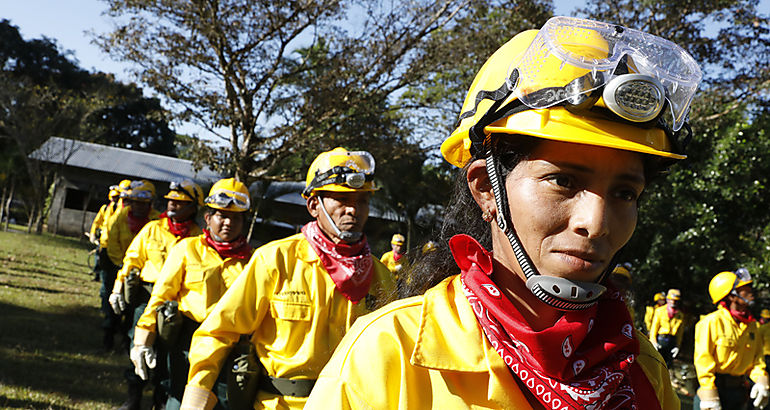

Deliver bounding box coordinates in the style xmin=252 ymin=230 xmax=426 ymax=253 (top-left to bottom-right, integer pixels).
xmin=302 ymin=147 xmax=378 ymax=199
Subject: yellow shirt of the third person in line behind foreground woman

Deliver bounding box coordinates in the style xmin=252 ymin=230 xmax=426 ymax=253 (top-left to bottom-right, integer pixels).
xmin=115 ymin=218 xmax=203 ymax=286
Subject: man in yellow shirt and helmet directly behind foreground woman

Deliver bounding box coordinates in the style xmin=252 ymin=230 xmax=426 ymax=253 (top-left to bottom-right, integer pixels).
xmin=182 ymin=147 xmax=394 ymax=409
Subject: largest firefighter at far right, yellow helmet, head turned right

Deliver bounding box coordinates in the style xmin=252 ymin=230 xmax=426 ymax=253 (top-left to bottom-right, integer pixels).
xmin=693 ymin=268 xmax=768 ymax=410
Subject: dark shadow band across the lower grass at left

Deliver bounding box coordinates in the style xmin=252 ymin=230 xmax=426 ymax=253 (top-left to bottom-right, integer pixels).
xmin=0 ymin=303 xmax=123 ymax=408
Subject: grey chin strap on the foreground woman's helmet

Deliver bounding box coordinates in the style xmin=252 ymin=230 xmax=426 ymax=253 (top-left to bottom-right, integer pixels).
xmin=484 ymin=135 xmax=612 ymax=310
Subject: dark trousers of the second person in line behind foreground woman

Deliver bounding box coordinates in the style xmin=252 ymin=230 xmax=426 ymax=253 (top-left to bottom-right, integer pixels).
xmin=166 ymin=315 xmax=229 ymax=410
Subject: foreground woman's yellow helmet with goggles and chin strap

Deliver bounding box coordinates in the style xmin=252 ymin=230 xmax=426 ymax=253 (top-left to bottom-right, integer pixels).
xmin=441 ymin=17 xmax=702 ymax=310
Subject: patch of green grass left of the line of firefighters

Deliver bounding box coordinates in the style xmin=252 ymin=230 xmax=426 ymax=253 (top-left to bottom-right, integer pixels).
xmin=0 ymin=227 xmax=128 ymax=409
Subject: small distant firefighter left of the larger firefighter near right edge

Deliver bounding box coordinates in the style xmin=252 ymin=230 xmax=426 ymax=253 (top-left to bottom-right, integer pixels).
xmin=650 ymin=289 xmax=684 ymax=369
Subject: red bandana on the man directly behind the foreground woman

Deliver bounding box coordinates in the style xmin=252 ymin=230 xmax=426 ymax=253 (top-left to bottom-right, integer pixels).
xmin=302 ymin=221 xmax=374 ymax=303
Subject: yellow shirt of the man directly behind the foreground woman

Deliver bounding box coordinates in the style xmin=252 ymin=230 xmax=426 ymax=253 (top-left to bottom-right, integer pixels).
xmin=188 ymin=233 xmax=395 ymax=409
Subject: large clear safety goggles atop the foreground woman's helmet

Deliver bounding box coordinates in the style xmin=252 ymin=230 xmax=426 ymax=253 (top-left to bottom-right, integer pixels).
xmin=508 ymin=17 xmax=703 ymax=131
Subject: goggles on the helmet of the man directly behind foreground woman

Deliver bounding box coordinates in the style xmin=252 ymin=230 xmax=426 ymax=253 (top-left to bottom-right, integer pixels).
xmin=302 ymin=151 xmax=375 ymax=196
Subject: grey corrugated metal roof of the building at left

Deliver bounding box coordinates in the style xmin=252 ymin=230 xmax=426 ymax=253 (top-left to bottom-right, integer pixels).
xmin=30 ymin=137 xmax=220 ymax=183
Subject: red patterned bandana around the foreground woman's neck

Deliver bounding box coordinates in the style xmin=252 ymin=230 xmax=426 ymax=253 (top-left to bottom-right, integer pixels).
xmin=449 ymin=235 xmax=660 ymax=410
